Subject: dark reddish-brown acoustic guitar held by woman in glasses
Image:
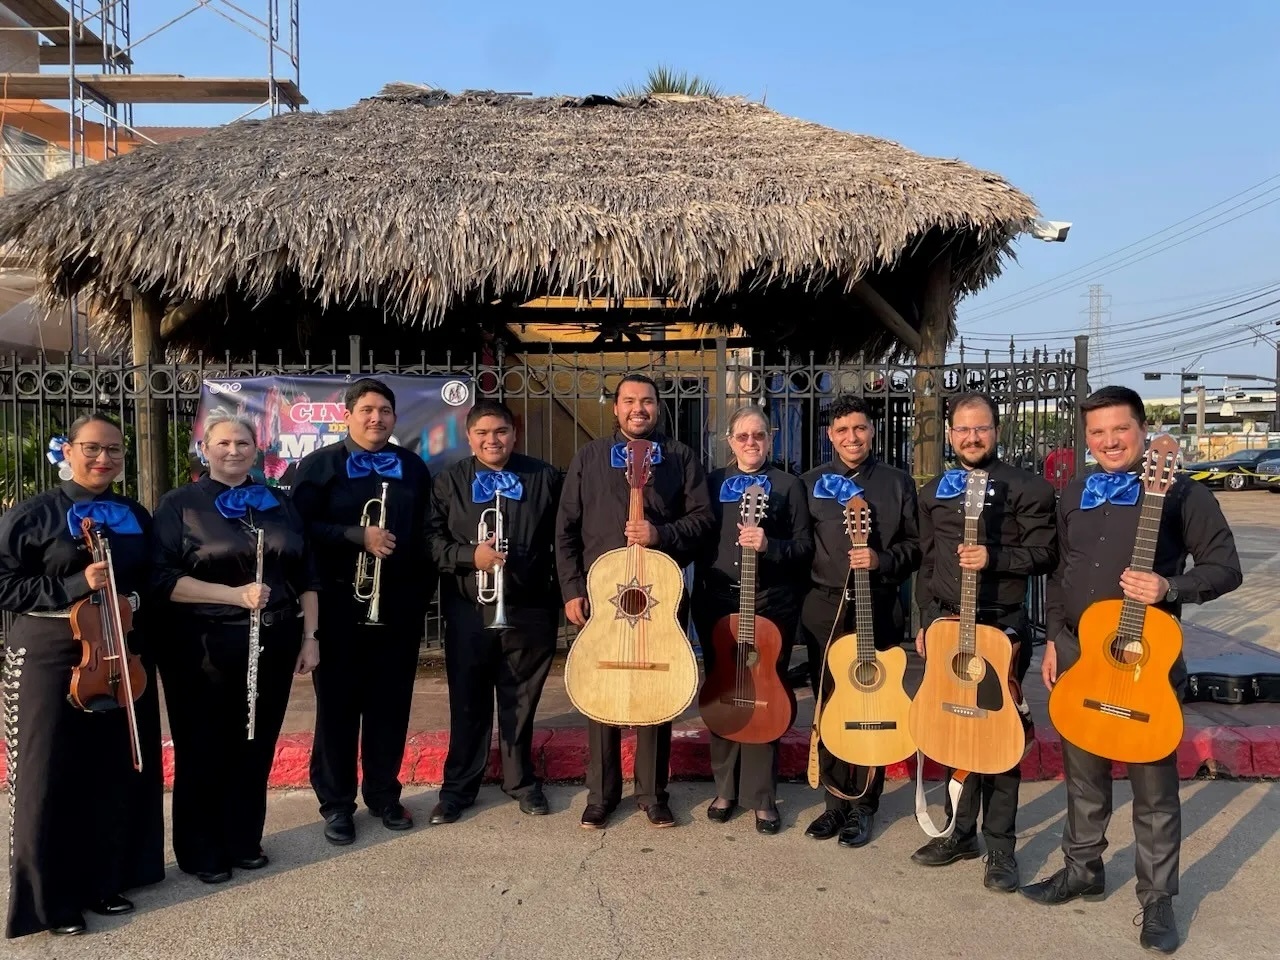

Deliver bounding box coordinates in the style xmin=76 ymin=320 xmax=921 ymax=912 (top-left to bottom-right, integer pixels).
xmin=698 ymin=484 xmax=796 ymax=744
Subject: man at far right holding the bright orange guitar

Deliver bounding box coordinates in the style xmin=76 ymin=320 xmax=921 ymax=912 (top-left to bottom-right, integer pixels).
xmin=1021 ymin=387 xmax=1243 ymax=954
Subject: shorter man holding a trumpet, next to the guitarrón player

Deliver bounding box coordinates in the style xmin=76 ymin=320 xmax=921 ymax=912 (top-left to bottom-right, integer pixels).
xmin=431 ymin=399 xmax=561 ymax=823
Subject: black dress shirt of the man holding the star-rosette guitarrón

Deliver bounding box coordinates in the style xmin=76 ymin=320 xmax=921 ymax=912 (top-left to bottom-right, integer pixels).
xmin=556 ymin=431 xmax=712 ymax=603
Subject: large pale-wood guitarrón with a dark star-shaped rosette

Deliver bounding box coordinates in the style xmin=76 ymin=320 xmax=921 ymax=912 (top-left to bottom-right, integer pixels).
xmin=564 ymin=440 xmax=698 ymax=727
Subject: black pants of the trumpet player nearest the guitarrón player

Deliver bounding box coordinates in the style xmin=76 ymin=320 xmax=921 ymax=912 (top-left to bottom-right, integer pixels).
xmin=440 ymin=596 xmax=557 ymax=806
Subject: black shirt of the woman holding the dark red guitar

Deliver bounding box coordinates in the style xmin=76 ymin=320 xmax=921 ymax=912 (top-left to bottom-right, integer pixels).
xmin=696 ymin=465 xmax=813 ymax=611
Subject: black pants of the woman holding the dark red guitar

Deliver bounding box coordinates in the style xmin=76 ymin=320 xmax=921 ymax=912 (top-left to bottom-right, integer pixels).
xmin=692 ymin=595 xmax=797 ymax=810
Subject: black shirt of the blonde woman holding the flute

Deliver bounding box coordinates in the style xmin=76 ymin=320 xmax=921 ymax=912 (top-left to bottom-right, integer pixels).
xmin=152 ymin=474 xmax=320 ymax=623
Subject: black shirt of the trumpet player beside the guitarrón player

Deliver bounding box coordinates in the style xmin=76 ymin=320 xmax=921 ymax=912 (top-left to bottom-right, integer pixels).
xmin=431 ymin=453 xmax=561 ymax=609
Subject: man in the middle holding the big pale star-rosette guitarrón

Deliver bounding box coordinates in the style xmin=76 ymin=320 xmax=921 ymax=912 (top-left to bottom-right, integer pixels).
xmin=556 ymin=374 xmax=713 ymax=829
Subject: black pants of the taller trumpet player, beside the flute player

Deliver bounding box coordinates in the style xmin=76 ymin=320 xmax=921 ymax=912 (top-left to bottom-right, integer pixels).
xmin=311 ymin=593 xmax=422 ymax=819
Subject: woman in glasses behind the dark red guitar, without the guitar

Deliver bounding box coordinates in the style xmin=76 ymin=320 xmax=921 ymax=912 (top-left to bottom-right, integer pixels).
xmin=692 ymin=406 xmax=813 ymax=835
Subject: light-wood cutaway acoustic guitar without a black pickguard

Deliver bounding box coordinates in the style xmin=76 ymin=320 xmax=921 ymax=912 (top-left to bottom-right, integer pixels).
xmin=819 ymin=497 xmax=915 ymax=767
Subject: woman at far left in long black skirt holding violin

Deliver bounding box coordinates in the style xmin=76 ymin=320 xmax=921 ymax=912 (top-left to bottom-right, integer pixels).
xmin=0 ymin=413 xmax=164 ymax=937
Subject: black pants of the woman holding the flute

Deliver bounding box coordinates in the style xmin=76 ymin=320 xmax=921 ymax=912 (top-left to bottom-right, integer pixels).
xmin=160 ymin=618 xmax=302 ymax=873
